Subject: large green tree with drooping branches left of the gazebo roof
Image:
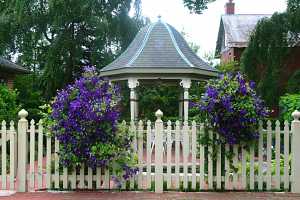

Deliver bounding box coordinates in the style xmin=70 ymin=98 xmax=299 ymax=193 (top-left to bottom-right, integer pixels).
xmin=0 ymin=0 xmax=143 ymax=99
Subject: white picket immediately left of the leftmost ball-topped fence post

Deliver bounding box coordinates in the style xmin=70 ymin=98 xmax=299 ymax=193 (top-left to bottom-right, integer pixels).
xmin=9 ymin=121 xmax=16 ymax=190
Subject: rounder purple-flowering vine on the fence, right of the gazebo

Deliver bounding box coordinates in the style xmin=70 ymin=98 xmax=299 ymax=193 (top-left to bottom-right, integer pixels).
xmin=198 ymin=73 xmax=268 ymax=144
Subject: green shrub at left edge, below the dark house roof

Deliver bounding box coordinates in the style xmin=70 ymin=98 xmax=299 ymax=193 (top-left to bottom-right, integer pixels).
xmin=0 ymin=84 xmax=19 ymax=122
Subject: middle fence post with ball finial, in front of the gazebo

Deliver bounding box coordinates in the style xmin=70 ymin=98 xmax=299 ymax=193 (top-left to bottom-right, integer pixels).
xmin=155 ymin=110 xmax=164 ymax=193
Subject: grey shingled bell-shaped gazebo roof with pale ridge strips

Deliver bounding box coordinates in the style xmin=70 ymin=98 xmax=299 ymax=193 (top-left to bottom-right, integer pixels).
xmin=100 ymin=20 xmax=218 ymax=79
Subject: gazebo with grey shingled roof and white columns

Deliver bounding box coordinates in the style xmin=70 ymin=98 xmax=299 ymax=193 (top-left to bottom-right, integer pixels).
xmin=100 ymin=19 xmax=218 ymax=121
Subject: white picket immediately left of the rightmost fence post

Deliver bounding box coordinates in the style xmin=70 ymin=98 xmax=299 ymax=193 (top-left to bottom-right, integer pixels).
xmin=284 ymin=121 xmax=290 ymax=190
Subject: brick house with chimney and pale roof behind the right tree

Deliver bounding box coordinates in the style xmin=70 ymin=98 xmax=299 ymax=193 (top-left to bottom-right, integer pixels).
xmin=215 ymin=0 xmax=300 ymax=88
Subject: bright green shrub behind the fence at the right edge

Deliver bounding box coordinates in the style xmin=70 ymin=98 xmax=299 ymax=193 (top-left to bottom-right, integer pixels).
xmin=279 ymin=94 xmax=300 ymax=121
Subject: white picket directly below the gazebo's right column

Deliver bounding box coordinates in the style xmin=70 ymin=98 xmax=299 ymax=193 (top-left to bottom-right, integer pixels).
xmin=182 ymin=121 xmax=190 ymax=189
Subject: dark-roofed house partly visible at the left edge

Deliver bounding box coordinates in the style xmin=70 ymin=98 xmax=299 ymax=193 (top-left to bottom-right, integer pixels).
xmin=0 ymin=57 xmax=30 ymax=89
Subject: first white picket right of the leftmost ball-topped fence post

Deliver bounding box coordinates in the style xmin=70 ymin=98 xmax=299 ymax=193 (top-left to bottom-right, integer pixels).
xmin=29 ymin=119 xmax=35 ymax=190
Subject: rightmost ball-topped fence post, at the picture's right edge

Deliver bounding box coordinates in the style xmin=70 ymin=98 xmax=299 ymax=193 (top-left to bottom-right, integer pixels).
xmin=291 ymin=110 xmax=300 ymax=193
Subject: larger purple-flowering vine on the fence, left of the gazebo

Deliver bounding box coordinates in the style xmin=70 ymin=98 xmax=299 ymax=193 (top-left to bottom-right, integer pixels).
xmin=51 ymin=67 xmax=136 ymax=184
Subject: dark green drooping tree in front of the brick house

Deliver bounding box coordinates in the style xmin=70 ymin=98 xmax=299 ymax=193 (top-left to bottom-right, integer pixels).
xmin=241 ymin=0 xmax=300 ymax=106
